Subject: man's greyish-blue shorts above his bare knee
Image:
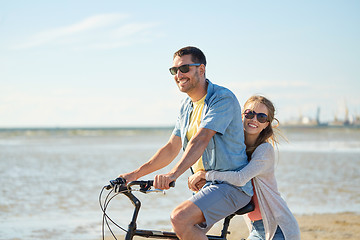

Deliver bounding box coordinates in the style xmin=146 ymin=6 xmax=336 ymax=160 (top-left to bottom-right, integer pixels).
xmin=189 ymin=183 xmax=251 ymax=228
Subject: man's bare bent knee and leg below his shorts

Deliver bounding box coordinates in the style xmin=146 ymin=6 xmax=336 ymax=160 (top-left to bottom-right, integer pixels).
xmin=171 ymin=201 xmax=208 ymax=240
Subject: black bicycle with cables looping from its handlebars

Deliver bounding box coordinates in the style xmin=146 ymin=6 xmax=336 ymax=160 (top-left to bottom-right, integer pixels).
xmin=99 ymin=178 xmax=255 ymax=240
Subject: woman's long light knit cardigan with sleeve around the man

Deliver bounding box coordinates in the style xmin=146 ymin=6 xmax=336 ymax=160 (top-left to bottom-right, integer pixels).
xmin=206 ymin=143 xmax=300 ymax=240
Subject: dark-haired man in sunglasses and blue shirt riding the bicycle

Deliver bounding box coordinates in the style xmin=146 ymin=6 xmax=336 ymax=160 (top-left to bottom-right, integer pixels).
xmin=120 ymin=47 xmax=253 ymax=240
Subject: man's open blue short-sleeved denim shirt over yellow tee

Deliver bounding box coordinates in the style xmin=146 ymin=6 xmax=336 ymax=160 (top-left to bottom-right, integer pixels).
xmin=173 ymin=79 xmax=253 ymax=196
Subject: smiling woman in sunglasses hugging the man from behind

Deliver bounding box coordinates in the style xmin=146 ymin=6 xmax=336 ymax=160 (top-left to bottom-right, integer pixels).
xmin=188 ymin=96 xmax=300 ymax=240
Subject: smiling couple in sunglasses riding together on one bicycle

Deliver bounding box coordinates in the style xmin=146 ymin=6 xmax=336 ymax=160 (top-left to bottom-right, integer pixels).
xmin=119 ymin=47 xmax=300 ymax=240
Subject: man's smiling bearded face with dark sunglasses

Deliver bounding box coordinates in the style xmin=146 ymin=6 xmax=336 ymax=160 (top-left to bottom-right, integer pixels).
xmin=173 ymin=55 xmax=200 ymax=95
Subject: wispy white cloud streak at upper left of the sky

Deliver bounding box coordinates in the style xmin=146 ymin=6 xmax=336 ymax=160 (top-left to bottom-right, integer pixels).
xmin=12 ymin=14 xmax=157 ymax=50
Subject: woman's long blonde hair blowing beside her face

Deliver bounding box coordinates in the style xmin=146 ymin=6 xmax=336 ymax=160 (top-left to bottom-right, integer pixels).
xmin=244 ymin=95 xmax=279 ymax=159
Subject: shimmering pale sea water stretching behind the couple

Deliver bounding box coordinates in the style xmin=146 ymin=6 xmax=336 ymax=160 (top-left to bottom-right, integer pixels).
xmin=0 ymin=128 xmax=360 ymax=239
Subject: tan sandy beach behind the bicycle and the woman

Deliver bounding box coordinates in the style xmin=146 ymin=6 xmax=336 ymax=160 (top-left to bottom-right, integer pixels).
xmin=119 ymin=213 xmax=360 ymax=240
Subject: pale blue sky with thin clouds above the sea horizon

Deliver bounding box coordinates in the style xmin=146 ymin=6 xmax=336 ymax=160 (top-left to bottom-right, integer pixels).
xmin=0 ymin=0 xmax=360 ymax=128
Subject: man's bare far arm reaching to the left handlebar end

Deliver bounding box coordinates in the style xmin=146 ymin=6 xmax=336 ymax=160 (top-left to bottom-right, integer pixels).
xmin=119 ymin=134 xmax=181 ymax=182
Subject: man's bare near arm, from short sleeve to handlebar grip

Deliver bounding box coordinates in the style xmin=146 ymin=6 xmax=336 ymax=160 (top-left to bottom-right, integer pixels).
xmin=154 ymin=128 xmax=216 ymax=189
